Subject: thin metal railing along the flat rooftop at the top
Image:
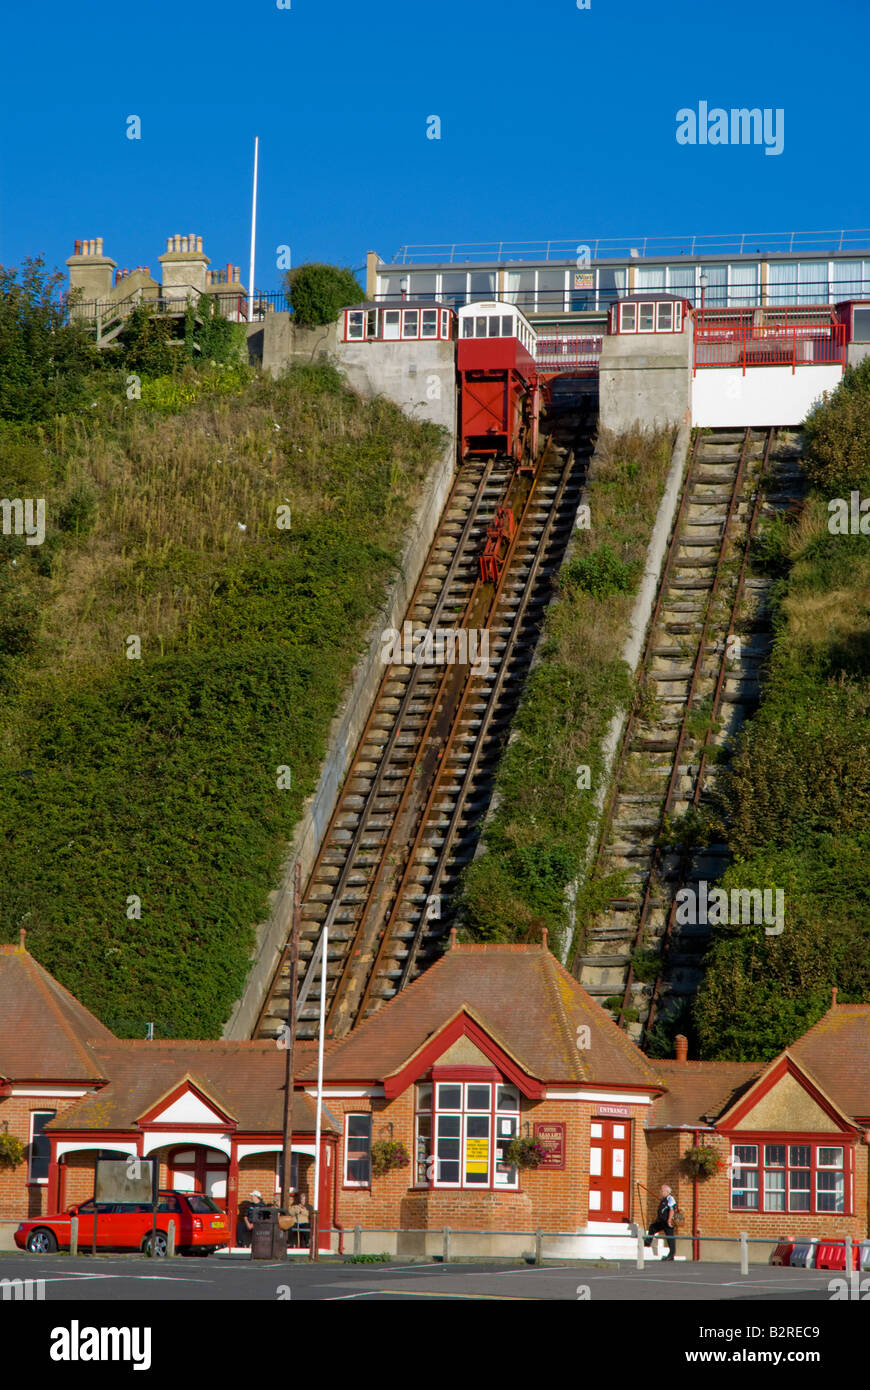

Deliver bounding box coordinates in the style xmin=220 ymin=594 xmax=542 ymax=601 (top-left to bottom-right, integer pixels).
xmin=391 ymin=228 xmax=870 ymax=265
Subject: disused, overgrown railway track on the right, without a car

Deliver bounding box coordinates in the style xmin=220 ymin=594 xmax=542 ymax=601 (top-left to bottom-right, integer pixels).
xmin=573 ymin=430 xmax=802 ymax=1041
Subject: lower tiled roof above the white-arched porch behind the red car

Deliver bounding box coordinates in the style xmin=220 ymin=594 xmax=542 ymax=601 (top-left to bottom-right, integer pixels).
xmin=49 ymin=1038 xmax=340 ymax=1134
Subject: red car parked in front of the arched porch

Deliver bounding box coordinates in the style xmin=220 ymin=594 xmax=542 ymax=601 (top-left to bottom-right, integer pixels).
xmin=15 ymin=1191 xmax=229 ymax=1255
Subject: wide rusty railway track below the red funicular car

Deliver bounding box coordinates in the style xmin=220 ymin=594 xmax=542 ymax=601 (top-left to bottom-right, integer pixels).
xmin=256 ymin=405 xmax=592 ymax=1038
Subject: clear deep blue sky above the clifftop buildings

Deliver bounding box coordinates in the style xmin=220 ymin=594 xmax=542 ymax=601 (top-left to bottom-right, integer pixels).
xmin=0 ymin=0 xmax=870 ymax=289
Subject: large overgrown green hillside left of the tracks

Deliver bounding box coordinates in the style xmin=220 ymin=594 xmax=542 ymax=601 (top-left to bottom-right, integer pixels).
xmin=0 ymin=263 xmax=442 ymax=1037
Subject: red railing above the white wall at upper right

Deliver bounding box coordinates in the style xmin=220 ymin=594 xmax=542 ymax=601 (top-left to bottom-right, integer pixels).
xmin=695 ymin=322 xmax=846 ymax=375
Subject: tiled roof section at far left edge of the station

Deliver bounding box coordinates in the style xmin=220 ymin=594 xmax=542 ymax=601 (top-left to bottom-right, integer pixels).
xmin=0 ymin=945 xmax=114 ymax=1081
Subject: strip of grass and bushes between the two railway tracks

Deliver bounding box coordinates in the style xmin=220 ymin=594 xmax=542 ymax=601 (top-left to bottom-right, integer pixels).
xmin=461 ymin=434 xmax=673 ymax=951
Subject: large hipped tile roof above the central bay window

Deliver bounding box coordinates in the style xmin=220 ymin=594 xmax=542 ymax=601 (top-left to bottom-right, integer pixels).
xmin=299 ymin=945 xmax=660 ymax=1090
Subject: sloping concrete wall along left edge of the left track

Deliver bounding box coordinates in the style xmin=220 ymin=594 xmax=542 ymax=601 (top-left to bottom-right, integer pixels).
xmin=222 ymin=436 xmax=454 ymax=1038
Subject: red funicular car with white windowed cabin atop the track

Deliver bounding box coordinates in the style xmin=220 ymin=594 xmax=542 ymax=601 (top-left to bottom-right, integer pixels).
xmin=456 ymin=299 xmax=539 ymax=464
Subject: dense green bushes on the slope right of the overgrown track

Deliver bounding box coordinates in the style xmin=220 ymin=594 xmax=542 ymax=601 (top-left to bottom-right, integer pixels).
xmin=695 ymin=361 xmax=870 ymax=1059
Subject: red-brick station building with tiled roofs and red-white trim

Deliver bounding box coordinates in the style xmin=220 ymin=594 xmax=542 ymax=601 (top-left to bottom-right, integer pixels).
xmin=0 ymin=944 xmax=870 ymax=1259
